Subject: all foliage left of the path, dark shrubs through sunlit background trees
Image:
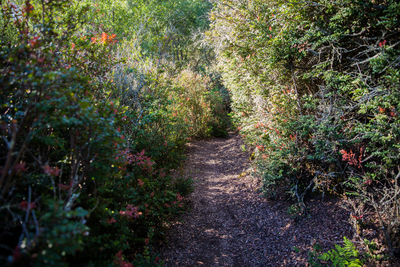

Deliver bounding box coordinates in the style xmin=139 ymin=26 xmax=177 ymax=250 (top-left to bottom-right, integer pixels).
xmin=0 ymin=0 xmax=228 ymax=266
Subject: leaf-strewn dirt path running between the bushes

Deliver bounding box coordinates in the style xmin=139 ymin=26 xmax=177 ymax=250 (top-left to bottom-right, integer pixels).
xmin=159 ymin=135 xmax=352 ymax=266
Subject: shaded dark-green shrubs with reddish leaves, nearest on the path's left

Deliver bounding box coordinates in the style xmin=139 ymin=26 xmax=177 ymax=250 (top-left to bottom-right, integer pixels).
xmin=0 ymin=1 xmax=203 ymax=266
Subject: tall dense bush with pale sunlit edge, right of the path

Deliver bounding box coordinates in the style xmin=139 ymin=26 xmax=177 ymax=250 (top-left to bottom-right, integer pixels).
xmin=208 ymin=0 xmax=400 ymax=262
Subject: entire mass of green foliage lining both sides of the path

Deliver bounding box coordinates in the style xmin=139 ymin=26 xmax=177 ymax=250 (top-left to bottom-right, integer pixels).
xmin=0 ymin=0 xmax=400 ymax=266
